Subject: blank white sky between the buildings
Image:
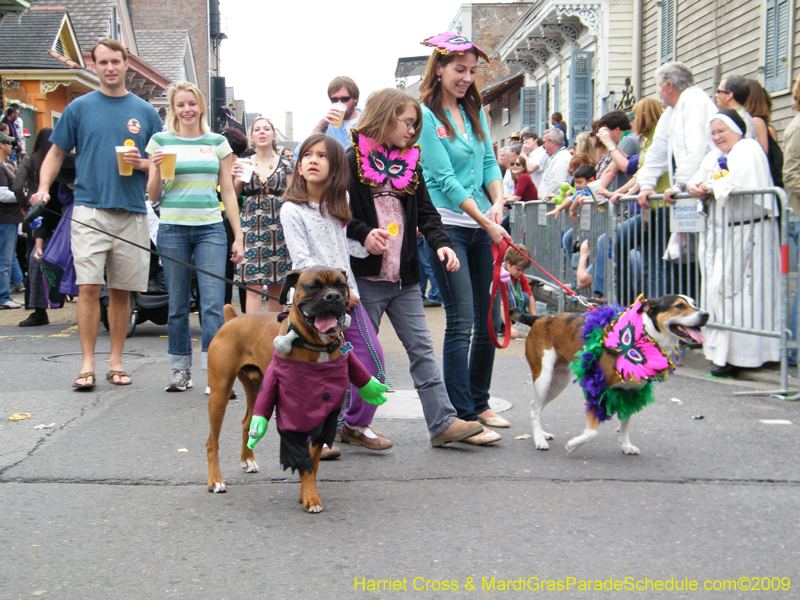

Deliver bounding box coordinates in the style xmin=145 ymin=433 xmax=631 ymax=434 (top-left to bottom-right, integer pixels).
xmin=220 ymin=0 xmax=510 ymax=140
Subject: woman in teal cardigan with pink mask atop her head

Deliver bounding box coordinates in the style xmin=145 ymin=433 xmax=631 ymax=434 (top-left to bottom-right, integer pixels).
xmin=419 ymin=33 xmax=510 ymax=445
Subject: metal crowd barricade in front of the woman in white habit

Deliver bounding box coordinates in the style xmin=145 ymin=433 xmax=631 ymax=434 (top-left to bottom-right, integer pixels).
xmin=604 ymin=188 xmax=798 ymax=395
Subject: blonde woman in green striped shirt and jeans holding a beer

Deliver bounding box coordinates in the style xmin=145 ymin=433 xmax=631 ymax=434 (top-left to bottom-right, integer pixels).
xmin=147 ymin=82 xmax=243 ymax=392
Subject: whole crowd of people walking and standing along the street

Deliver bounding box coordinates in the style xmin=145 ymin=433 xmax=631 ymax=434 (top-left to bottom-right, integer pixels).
xmin=0 ymin=33 xmax=800 ymax=458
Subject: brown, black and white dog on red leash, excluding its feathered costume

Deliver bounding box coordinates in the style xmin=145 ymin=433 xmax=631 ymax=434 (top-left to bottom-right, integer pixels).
xmin=511 ymin=295 xmax=708 ymax=454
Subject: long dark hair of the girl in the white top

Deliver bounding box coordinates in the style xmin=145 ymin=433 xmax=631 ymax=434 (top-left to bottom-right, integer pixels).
xmin=283 ymin=133 xmax=352 ymax=223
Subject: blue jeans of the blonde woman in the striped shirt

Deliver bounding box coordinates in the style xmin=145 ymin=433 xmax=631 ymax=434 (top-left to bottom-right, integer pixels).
xmin=157 ymin=222 xmax=227 ymax=369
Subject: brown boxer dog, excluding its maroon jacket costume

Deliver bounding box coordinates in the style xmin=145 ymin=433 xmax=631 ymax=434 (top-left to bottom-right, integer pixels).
xmin=206 ymin=266 xmax=350 ymax=512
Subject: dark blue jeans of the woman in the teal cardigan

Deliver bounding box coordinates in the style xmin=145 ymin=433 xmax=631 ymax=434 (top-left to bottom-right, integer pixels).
xmin=427 ymin=225 xmax=501 ymax=421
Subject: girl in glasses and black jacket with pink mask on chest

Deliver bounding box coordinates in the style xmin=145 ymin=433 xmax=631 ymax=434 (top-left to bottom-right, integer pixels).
xmin=341 ymin=88 xmax=483 ymax=449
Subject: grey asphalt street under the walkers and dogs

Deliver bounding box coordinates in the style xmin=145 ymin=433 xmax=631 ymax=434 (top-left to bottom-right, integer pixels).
xmin=0 ymin=300 xmax=800 ymax=600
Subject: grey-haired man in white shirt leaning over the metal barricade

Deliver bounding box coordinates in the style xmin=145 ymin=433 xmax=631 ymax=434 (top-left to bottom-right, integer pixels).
xmin=636 ymin=62 xmax=717 ymax=298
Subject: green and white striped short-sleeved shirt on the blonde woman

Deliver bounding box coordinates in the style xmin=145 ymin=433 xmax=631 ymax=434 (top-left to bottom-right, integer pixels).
xmin=146 ymin=131 xmax=231 ymax=225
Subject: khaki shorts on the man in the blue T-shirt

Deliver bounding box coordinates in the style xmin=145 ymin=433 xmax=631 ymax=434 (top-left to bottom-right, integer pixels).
xmin=72 ymin=206 xmax=150 ymax=291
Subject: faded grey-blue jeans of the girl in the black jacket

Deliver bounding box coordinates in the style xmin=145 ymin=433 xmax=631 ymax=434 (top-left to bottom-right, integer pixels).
xmin=357 ymin=278 xmax=456 ymax=438
